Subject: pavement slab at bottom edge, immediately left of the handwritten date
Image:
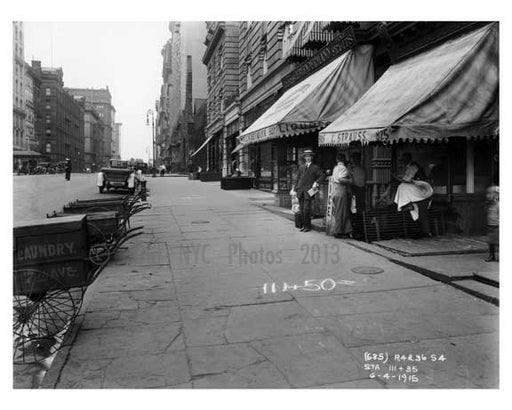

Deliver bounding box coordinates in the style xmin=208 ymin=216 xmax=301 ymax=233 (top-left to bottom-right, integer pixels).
xmin=251 ymin=333 xmax=365 ymax=388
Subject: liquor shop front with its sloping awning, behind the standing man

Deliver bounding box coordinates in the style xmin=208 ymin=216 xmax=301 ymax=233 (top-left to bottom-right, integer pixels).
xmin=234 ymin=45 xmax=374 ymax=206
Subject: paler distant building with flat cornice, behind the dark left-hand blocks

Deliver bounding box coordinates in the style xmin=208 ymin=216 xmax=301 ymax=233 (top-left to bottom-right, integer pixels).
xmin=66 ymin=86 xmax=116 ymax=165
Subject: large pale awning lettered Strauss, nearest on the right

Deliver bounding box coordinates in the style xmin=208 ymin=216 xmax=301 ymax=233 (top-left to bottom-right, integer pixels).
xmin=318 ymin=23 xmax=499 ymax=145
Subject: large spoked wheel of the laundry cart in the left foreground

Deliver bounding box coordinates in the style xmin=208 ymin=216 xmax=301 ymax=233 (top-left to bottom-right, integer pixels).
xmin=13 ymin=269 xmax=83 ymax=364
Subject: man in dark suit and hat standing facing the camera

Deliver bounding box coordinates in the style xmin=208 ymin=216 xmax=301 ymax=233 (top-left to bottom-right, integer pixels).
xmin=291 ymin=149 xmax=325 ymax=232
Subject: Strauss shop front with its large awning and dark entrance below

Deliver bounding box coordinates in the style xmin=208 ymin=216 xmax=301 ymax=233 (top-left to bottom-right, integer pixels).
xmin=319 ymin=24 xmax=499 ymax=234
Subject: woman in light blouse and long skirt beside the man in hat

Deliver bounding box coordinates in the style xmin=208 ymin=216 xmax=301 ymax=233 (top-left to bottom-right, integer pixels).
xmin=331 ymin=154 xmax=352 ymax=238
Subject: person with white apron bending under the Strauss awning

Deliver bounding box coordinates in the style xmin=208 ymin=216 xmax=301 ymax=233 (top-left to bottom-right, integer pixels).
xmin=394 ymin=152 xmax=434 ymax=237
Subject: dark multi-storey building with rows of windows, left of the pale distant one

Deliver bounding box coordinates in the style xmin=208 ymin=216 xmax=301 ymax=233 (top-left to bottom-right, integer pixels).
xmin=32 ymin=61 xmax=84 ymax=171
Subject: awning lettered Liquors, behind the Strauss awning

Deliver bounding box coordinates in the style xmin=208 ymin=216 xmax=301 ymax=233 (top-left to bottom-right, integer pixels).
xmin=238 ymin=45 xmax=374 ymax=146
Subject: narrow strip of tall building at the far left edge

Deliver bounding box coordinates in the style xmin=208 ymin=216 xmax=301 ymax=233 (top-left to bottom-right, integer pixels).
xmin=12 ymin=21 xmax=25 ymax=150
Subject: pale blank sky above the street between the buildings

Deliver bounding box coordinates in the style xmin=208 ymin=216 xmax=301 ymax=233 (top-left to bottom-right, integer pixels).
xmin=24 ymin=21 xmax=170 ymax=160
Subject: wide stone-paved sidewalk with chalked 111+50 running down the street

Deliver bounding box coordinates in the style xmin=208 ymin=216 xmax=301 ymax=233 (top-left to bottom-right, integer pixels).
xmin=30 ymin=178 xmax=499 ymax=389
